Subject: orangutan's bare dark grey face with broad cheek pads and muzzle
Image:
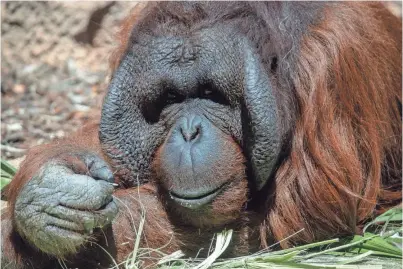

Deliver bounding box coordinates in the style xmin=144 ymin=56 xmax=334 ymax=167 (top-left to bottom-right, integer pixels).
xmin=100 ymin=26 xmax=280 ymax=211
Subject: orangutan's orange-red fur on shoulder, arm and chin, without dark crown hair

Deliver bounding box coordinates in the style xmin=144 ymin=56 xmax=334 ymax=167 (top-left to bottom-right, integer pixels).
xmin=3 ymin=2 xmax=402 ymax=266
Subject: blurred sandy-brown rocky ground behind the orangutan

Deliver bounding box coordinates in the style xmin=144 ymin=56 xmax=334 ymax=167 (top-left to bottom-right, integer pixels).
xmin=1 ymin=1 xmax=402 ymax=165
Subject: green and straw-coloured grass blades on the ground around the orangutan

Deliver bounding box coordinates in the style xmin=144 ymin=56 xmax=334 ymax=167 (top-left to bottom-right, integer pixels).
xmin=1 ymin=160 xmax=402 ymax=269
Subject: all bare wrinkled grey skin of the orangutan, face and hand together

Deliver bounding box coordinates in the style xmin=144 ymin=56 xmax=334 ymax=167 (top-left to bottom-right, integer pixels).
xmin=3 ymin=15 xmax=281 ymax=264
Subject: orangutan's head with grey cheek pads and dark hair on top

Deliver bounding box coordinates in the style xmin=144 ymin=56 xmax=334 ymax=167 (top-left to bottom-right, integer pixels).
xmin=99 ymin=2 xmax=321 ymax=217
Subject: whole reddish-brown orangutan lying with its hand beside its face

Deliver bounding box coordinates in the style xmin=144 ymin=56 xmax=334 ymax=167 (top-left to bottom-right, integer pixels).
xmin=1 ymin=1 xmax=402 ymax=269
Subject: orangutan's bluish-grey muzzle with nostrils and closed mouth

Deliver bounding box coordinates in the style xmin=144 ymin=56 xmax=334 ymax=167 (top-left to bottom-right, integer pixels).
xmin=159 ymin=104 xmax=240 ymax=201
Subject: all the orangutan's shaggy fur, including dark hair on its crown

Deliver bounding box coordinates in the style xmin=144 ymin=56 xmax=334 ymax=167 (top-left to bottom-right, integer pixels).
xmin=3 ymin=2 xmax=402 ymax=266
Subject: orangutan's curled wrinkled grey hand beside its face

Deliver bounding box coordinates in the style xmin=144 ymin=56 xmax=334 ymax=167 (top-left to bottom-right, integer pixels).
xmin=15 ymin=154 xmax=118 ymax=257
